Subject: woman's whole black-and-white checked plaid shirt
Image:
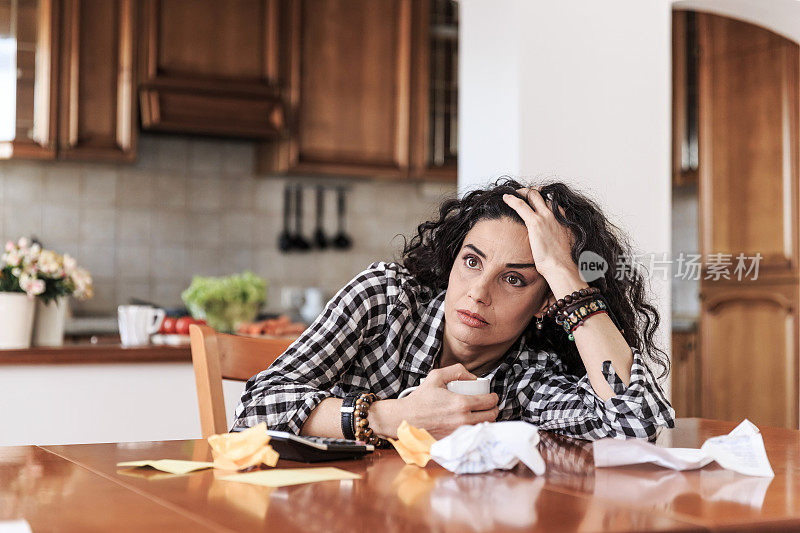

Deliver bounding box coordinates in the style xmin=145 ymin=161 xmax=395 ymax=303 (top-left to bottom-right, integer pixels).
xmin=233 ymin=263 xmax=675 ymax=440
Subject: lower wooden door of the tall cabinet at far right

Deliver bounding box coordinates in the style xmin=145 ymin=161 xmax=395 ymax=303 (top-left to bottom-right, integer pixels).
xmin=700 ymin=282 xmax=798 ymax=428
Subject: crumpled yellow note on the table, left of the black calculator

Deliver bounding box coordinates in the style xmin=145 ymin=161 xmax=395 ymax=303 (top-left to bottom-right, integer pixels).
xmin=208 ymin=422 xmax=278 ymax=470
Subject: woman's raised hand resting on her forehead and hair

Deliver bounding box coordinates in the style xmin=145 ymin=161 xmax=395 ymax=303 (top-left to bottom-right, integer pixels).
xmin=503 ymin=187 xmax=578 ymax=279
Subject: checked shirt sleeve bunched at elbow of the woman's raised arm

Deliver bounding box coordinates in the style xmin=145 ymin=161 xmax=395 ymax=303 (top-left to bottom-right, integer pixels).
xmin=517 ymin=348 xmax=675 ymax=440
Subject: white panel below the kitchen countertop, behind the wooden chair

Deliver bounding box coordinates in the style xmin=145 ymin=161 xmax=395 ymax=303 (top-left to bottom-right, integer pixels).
xmin=0 ymin=363 xmax=244 ymax=446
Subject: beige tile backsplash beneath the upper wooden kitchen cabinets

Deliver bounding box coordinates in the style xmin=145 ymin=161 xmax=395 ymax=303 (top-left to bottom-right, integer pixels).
xmin=0 ymin=135 xmax=456 ymax=314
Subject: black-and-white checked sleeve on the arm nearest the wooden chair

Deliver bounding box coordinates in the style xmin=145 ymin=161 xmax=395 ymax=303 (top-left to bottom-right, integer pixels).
xmin=232 ymin=264 xmax=387 ymax=434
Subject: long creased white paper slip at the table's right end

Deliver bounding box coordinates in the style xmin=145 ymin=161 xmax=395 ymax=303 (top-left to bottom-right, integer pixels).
xmin=593 ymin=419 xmax=775 ymax=477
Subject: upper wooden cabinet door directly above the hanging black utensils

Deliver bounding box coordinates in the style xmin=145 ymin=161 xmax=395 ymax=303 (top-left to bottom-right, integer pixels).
xmin=262 ymin=0 xmax=411 ymax=178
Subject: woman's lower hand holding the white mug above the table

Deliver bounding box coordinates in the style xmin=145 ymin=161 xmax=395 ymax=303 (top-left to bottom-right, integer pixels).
xmin=392 ymin=364 xmax=499 ymax=439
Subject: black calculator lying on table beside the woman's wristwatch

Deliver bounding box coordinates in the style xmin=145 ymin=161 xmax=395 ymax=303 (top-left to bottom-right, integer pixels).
xmin=267 ymin=430 xmax=375 ymax=463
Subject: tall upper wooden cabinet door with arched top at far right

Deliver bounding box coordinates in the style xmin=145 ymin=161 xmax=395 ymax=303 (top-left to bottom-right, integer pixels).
xmin=698 ymin=15 xmax=800 ymax=274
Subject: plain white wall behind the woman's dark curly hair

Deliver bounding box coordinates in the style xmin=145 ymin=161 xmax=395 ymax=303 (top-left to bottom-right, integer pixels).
xmin=459 ymin=0 xmax=671 ymax=354
